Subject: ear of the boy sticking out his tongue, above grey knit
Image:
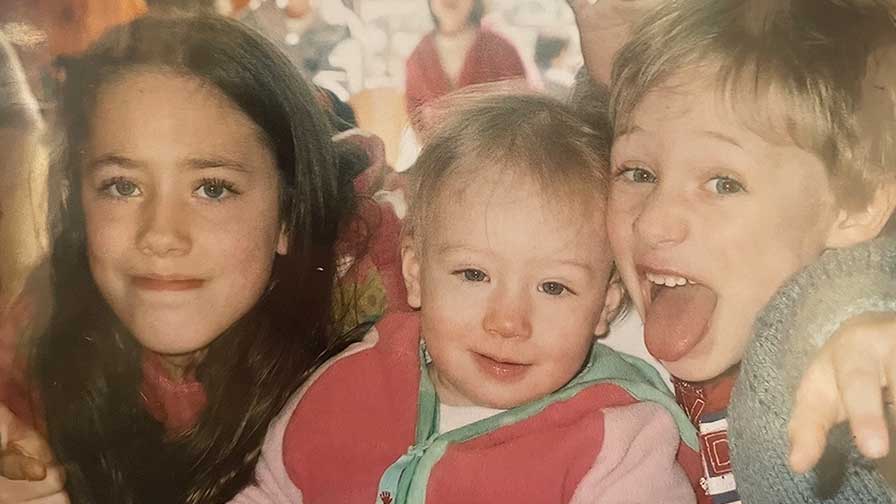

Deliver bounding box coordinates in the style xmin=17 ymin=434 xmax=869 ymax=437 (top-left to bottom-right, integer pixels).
xmin=825 ymin=183 xmax=896 ymax=248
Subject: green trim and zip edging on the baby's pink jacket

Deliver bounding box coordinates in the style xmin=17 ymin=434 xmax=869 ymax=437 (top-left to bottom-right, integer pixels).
xmin=377 ymin=343 xmax=698 ymax=504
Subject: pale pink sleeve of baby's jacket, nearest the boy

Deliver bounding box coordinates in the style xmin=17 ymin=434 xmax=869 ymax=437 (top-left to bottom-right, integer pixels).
xmin=570 ymin=402 xmax=696 ymax=504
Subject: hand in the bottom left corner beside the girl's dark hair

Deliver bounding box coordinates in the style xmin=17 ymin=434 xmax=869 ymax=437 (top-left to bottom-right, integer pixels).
xmin=0 ymin=405 xmax=69 ymax=504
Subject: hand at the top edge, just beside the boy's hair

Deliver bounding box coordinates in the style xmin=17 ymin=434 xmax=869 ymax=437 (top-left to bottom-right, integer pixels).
xmin=566 ymin=0 xmax=663 ymax=84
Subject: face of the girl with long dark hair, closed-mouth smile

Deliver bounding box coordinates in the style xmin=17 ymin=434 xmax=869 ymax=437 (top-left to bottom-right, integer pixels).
xmin=81 ymin=70 xmax=287 ymax=359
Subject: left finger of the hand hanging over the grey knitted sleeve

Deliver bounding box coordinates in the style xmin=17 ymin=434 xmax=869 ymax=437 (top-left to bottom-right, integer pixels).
xmin=787 ymin=361 xmax=845 ymax=473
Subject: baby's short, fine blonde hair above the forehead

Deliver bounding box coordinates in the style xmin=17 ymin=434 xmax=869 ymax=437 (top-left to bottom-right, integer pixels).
xmin=404 ymin=85 xmax=610 ymax=243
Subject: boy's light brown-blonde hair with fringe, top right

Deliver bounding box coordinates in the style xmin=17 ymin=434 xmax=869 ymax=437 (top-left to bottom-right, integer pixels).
xmin=611 ymin=0 xmax=896 ymax=208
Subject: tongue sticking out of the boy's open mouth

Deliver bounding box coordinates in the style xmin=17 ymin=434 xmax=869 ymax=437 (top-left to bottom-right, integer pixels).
xmin=644 ymin=284 xmax=716 ymax=362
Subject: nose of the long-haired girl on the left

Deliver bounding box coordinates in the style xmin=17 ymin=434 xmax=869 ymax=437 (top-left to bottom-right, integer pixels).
xmin=137 ymin=196 xmax=191 ymax=257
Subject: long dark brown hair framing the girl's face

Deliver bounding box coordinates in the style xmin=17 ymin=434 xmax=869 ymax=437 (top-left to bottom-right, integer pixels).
xmin=32 ymin=16 xmax=353 ymax=504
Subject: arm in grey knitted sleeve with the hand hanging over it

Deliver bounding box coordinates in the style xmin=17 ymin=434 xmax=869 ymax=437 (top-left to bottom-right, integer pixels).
xmin=729 ymin=239 xmax=896 ymax=502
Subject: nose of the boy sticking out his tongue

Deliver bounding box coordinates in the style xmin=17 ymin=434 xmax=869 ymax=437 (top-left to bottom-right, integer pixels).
xmin=634 ymin=188 xmax=689 ymax=248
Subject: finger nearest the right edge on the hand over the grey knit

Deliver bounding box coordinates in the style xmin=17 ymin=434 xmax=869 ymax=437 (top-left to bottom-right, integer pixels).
xmin=835 ymin=352 xmax=890 ymax=459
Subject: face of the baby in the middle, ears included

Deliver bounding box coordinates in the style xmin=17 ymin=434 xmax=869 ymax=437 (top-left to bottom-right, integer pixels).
xmin=404 ymin=169 xmax=619 ymax=409
